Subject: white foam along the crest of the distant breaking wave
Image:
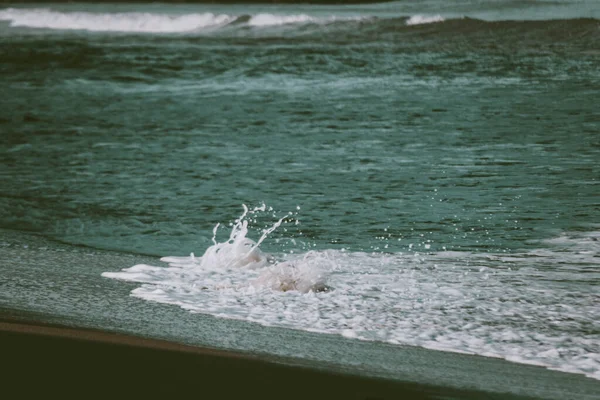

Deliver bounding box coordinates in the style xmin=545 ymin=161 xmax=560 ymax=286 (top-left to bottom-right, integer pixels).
xmin=0 ymin=8 xmax=444 ymax=33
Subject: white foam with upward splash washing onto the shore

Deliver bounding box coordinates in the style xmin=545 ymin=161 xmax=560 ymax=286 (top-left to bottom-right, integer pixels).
xmin=103 ymin=206 xmax=600 ymax=379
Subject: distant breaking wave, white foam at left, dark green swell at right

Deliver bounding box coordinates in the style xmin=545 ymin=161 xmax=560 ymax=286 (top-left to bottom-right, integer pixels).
xmin=0 ymin=8 xmax=600 ymax=47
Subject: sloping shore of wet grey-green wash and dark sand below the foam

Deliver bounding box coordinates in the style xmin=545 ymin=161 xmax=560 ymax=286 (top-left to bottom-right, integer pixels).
xmin=0 ymin=229 xmax=600 ymax=400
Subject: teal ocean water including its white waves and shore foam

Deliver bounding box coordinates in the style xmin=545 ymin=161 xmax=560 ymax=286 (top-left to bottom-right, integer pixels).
xmin=0 ymin=0 xmax=600 ymax=398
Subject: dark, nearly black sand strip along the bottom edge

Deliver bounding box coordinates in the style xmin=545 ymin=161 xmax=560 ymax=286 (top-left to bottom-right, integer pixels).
xmin=0 ymin=319 xmax=528 ymax=400
